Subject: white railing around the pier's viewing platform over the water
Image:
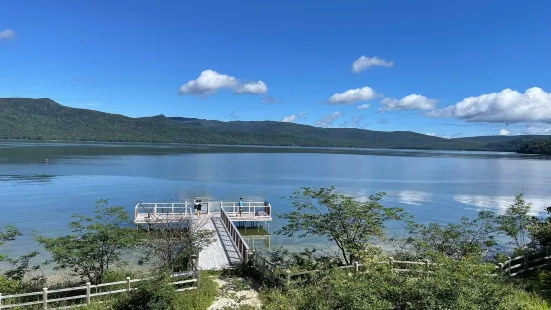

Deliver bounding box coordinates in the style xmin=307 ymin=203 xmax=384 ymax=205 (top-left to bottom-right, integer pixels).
xmin=134 ymin=201 xmax=272 ymax=221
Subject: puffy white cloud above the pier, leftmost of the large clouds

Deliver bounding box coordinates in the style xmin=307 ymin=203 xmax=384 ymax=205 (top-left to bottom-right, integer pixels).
xmin=179 ymin=70 xmax=268 ymax=96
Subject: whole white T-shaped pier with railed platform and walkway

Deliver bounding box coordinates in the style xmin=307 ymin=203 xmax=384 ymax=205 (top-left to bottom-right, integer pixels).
xmin=134 ymin=201 xmax=272 ymax=270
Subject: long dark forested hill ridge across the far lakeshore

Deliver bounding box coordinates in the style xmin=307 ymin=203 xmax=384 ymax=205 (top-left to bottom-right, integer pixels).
xmin=0 ymin=98 xmax=548 ymax=151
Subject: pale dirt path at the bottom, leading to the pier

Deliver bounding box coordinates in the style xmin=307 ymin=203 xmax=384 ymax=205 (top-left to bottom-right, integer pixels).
xmin=209 ymin=277 xmax=262 ymax=310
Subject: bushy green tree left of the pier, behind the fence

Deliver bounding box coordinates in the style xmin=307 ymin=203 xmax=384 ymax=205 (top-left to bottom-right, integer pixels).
xmin=36 ymin=200 xmax=137 ymax=283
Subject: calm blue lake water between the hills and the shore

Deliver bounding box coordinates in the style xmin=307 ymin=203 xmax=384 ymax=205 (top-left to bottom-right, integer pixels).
xmin=0 ymin=141 xmax=551 ymax=262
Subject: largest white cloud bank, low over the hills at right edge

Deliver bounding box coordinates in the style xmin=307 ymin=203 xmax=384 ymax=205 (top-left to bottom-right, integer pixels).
xmin=427 ymin=87 xmax=551 ymax=124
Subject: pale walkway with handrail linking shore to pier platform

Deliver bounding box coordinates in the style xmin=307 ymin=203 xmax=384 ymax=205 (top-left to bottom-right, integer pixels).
xmin=196 ymin=214 xmax=241 ymax=270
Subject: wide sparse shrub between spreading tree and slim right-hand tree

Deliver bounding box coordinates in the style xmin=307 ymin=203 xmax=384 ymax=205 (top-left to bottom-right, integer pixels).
xmin=399 ymin=211 xmax=497 ymax=259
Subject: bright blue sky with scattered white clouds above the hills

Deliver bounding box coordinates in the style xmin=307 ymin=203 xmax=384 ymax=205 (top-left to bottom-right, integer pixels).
xmin=0 ymin=0 xmax=551 ymax=137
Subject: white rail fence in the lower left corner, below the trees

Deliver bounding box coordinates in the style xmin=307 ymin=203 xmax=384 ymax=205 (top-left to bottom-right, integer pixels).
xmin=0 ymin=270 xmax=199 ymax=310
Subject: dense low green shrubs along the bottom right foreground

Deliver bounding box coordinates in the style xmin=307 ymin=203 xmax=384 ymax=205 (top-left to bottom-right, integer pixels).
xmin=262 ymin=260 xmax=549 ymax=310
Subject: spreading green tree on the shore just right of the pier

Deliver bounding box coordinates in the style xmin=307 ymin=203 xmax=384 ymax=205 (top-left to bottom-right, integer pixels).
xmin=276 ymin=187 xmax=407 ymax=264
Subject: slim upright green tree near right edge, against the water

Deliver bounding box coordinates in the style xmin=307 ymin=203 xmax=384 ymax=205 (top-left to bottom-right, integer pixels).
xmin=497 ymin=193 xmax=537 ymax=252
